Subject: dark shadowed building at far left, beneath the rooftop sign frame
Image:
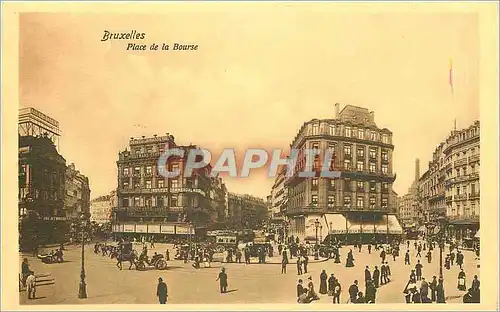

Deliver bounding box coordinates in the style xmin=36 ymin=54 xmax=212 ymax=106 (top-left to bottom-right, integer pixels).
xmin=18 ymin=135 xmax=68 ymax=248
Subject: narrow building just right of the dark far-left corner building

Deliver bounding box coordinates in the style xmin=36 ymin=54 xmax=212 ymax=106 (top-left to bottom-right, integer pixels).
xmin=64 ymin=163 xmax=90 ymax=220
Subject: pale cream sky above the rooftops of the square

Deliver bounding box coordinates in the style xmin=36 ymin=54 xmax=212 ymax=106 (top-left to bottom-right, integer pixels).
xmin=19 ymin=9 xmax=479 ymax=198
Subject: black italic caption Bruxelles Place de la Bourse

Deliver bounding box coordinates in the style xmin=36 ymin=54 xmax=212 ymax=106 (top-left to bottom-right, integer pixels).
xmin=101 ymin=30 xmax=198 ymax=51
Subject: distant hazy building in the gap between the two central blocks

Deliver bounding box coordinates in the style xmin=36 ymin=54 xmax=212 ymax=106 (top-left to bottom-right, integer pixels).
xmin=228 ymin=193 xmax=267 ymax=229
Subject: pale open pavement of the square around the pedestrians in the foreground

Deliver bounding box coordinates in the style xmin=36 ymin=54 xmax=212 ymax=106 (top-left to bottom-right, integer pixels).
xmin=20 ymin=244 xmax=480 ymax=304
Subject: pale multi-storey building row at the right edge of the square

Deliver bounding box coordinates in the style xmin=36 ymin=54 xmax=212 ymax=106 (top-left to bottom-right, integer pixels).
xmin=420 ymin=121 xmax=480 ymax=240
